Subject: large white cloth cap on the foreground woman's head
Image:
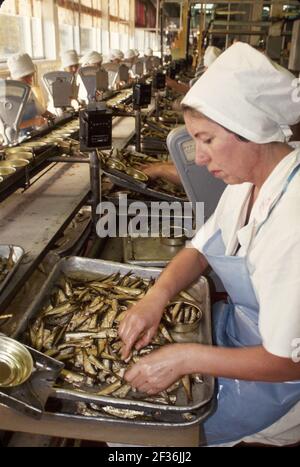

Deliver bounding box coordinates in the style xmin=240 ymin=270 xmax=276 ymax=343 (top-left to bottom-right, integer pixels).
xmin=182 ymin=42 xmax=300 ymax=144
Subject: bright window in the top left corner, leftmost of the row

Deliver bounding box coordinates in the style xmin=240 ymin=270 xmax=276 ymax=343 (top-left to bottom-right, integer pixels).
xmin=0 ymin=0 xmax=44 ymax=62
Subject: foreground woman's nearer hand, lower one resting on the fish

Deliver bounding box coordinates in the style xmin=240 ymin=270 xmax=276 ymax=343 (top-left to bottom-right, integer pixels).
xmin=125 ymin=344 xmax=185 ymax=394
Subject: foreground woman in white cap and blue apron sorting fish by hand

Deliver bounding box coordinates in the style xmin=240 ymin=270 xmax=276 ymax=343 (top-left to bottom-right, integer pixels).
xmin=119 ymin=43 xmax=300 ymax=445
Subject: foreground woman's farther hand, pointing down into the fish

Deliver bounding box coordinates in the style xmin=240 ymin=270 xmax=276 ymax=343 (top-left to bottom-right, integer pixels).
xmin=119 ymin=294 xmax=165 ymax=360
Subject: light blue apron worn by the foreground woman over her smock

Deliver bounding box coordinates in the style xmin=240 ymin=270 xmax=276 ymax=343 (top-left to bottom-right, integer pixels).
xmin=203 ymin=164 xmax=300 ymax=445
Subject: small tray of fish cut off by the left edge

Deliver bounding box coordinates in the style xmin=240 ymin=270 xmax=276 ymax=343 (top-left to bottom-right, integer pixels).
xmin=0 ymin=245 xmax=25 ymax=294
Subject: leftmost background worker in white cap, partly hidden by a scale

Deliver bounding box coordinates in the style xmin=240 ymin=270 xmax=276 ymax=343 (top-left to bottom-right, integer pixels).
xmin=7 ymin=53 xmax=54 ymax=136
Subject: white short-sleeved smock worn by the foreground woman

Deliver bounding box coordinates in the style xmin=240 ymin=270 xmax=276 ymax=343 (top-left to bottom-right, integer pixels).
xmin=188 ymin=148 xmax=300 ymax=445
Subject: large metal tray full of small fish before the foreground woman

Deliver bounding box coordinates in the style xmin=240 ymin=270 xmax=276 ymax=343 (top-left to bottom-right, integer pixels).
xmin=14 ymin=257 xmax=214 ymax=420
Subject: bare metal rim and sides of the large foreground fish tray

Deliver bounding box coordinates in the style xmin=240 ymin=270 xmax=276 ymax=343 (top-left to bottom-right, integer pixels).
xmin=12 ymin=256 xmax=214 ymax=418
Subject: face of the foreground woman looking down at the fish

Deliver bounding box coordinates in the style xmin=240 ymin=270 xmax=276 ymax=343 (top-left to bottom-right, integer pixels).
xmin=184 ymin=111 xmax=259 ymax=184
